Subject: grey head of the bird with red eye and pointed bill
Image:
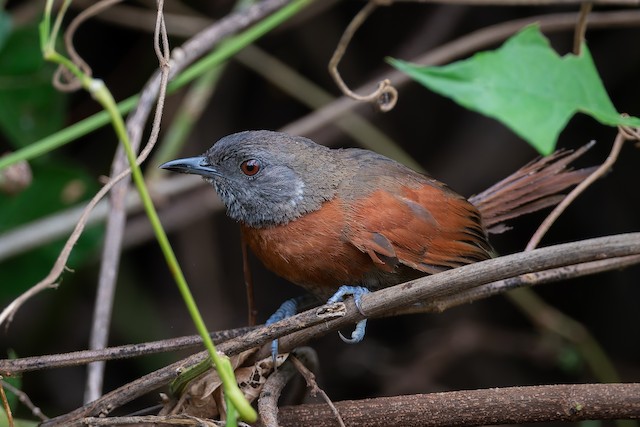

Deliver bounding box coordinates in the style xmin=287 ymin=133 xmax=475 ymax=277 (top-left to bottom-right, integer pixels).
xmin=160 ymin=130 xmax=340 ymax=227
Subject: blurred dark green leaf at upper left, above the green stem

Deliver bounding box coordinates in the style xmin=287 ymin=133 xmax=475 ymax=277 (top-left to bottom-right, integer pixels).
xmin=0 ymin=22 xmax=67 ymax=148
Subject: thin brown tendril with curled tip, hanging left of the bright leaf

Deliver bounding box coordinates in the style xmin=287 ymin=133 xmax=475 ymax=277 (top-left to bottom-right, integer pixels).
xmin=329 ymin=0 xmax=398 ymax=112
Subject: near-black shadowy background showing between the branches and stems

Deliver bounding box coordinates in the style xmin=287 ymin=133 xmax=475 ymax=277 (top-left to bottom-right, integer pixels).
xmin=0 ymin=1 xmax=640 ymax=424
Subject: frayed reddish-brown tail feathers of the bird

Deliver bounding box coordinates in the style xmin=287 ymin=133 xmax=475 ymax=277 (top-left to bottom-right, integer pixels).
xmin=469 ymin=141 xmax=595 ymax=234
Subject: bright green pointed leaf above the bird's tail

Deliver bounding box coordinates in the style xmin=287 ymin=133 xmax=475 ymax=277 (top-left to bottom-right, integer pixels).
xmin=388 ymin=25 xmax=640 ymax=154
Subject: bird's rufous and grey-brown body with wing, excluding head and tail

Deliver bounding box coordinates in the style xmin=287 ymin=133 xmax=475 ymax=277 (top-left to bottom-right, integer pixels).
xmin=243 ymin=149 xmax=491 ymax=297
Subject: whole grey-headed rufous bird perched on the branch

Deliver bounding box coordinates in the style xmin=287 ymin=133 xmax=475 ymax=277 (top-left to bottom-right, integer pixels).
xmin=160 ymin=130 xmax=591 ymax=342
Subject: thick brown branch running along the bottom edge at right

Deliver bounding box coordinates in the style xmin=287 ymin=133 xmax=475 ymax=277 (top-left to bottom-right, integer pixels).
xmin=279 ymin=384 xmax=640 ymax=427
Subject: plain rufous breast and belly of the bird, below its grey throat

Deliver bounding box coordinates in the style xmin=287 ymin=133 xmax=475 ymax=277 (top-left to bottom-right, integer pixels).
xmin=242 ymin=201 xmax=378 ymax=298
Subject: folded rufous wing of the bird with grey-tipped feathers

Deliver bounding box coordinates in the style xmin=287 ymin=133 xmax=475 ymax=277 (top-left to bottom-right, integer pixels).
xmin=345 ymin=181 xmax=491 ymax=274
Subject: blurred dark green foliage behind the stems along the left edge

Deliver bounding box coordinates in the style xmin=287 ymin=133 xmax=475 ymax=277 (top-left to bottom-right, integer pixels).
xmin=0 ymin=19 xmax=102 ymax=301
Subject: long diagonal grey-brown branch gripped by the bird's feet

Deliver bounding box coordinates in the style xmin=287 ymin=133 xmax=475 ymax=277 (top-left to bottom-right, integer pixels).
xmin=36 ymin=233 xmax=640 ymax=425
